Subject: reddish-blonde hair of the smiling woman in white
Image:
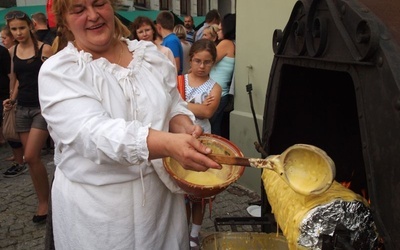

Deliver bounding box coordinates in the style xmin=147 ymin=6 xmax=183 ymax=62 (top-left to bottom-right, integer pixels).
xmin=52 ymin=0 xmax=131 ymax=52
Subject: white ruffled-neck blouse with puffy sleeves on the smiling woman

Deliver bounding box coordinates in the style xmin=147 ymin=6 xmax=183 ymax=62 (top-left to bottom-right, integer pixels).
xmin=39 ymin=39 xmax=194 ymax=191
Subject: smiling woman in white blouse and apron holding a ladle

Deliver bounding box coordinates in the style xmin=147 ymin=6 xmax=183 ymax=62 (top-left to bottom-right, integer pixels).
xmin=39 ymin=0 xmax=220 ymax=250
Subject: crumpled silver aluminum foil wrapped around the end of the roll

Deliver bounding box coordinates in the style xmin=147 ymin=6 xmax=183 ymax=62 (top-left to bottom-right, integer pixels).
xmin=298 ymin=200 xmax=378 ymax=249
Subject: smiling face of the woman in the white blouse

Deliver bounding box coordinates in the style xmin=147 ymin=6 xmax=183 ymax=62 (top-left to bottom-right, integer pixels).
xmin=65 ymin=0 xmax=115 ymax=52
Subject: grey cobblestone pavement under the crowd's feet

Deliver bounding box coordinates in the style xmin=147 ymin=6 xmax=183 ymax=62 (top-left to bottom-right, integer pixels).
xmin=0 ymin=146 xmax=260 ymax=250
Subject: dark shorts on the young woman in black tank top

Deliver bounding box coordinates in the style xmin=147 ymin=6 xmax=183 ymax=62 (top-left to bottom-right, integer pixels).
xmin=15 ymin=105 xmax=47 ymax=133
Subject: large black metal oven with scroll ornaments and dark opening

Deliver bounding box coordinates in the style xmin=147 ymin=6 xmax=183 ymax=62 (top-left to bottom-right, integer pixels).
xmin=262 ymin=0 xmax=400 ymax=249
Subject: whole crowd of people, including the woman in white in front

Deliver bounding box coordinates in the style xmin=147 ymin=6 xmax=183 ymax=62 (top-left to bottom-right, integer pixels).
xmin=0 ymin=0 xmax=236 ymax=249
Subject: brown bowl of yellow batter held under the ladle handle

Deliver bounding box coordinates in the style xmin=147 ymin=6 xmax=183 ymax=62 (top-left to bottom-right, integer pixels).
xmin=163 ymin=134 xmax=245 ymax=198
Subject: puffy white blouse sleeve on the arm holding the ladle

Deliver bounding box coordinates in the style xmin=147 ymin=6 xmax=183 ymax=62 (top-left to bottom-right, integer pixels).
xmin=39 ymin=44 xmax=150 ymax=165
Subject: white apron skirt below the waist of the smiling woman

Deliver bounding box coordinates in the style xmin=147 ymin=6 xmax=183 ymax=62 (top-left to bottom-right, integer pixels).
xmin=51 ymin=169 xmax=189 ymax=250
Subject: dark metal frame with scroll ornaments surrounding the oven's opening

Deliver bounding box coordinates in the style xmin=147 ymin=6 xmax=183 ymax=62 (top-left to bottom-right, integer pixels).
xmin=262 ymin=0 xmax=400 ymax=249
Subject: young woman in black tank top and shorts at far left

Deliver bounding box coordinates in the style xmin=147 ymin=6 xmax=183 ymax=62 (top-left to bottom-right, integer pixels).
xmin=3 ymin=11 xmax=53 ymax=223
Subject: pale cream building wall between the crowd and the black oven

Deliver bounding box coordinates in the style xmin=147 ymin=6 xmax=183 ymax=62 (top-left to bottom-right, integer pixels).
xmin=230 ymin=0 xmax=296 ymax=193
